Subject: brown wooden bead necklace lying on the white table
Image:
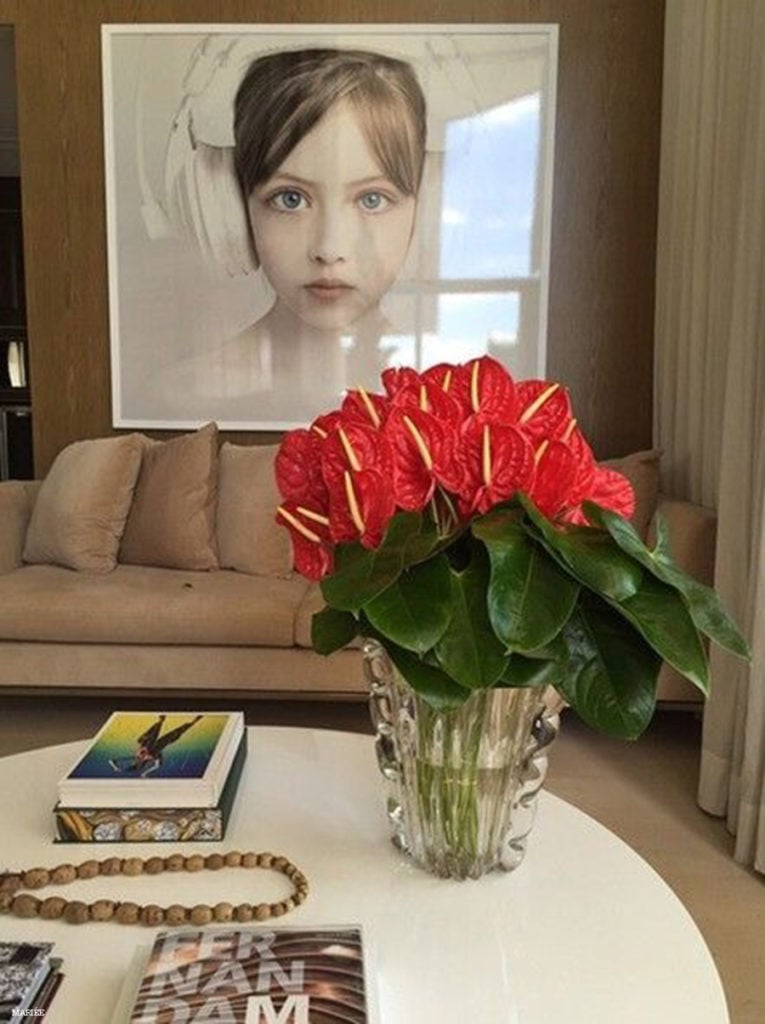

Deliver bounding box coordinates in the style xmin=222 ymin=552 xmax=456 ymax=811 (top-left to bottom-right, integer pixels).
xmin=0 ymin=850 xmax=308 ymax=928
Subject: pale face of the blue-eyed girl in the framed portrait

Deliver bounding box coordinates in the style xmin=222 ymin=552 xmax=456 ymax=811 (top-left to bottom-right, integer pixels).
xmin=248 ymin=101 xmax=415 ymax=331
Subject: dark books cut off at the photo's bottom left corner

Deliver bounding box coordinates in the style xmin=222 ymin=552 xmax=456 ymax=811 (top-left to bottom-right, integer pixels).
xmin=0 ymin=942 xmax=62 ymax=1024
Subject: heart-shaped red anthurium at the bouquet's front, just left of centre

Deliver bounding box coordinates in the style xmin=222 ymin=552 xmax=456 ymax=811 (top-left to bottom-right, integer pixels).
xmin=384 ymin=407 xmax=464 ymax=512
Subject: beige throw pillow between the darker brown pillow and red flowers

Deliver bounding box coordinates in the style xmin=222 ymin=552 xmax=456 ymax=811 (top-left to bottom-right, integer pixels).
xmin=217 ymin=442 xmax=292 ymax=577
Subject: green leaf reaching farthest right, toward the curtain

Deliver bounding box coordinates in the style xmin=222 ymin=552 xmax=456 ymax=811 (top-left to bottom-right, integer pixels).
xmin=585 ymin=502 xmax=750 ymax=658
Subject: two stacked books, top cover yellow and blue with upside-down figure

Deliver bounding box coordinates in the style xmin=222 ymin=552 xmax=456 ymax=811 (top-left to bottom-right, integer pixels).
xmin=53 ymin=712 xmax=247 ymax=843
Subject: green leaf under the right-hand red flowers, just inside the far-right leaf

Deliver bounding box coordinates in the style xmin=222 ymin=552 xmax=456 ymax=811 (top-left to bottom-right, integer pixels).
xmin=518 ymin=495 xmax=643 ymax=601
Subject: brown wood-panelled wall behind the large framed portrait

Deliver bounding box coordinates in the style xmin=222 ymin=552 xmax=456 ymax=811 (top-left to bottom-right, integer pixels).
xmin=0 ymin=0 xmax=664 ymax=474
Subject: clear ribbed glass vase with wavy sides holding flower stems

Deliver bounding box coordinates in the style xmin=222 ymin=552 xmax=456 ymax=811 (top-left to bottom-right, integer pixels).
xmin=364 ymin=640 xmax=562 ymax=879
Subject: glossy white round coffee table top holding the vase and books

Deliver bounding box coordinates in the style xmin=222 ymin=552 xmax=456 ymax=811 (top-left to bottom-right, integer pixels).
xmin=0 ymin=728 xmax=728 ymax=1024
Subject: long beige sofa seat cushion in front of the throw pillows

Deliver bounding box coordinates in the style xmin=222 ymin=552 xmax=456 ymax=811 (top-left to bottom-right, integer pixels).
xmin=0 ymin=565 xmax=309 ymax=643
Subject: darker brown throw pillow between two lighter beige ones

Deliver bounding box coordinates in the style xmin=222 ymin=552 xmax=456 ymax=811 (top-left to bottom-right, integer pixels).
xmin=120 ymin=423 xmax=218 ymax=569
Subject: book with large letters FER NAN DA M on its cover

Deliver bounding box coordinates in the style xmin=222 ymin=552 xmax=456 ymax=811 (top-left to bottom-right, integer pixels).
xmin=128 ymin=926 xmax=369 ymax=1024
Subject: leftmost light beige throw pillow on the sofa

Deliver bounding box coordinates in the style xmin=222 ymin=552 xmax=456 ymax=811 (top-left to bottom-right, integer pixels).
xmin=24 ymin=434 xmax=143 ymax=572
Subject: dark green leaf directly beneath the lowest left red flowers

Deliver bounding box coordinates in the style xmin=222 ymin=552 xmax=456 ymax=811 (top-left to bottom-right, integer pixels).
xmin=322 ymin=512 xmax=422 ymax=611
